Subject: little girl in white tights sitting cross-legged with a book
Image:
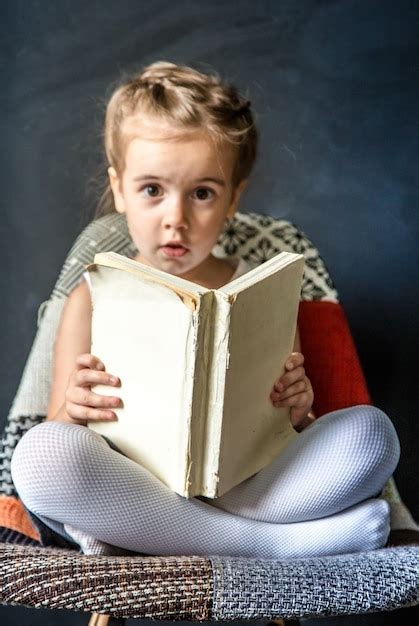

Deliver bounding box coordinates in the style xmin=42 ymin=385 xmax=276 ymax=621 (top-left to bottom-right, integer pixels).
xmin=12 ymin=62 xmax=399 ymax=559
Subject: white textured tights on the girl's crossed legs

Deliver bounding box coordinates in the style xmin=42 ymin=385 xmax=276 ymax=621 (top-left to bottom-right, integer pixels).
xmin=12 ymin=406 xmax=399 ymax=559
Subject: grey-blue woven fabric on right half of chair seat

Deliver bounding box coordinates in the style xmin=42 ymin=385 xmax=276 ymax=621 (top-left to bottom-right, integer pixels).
xmin=211 ymin=547 xmax=419 ymax=620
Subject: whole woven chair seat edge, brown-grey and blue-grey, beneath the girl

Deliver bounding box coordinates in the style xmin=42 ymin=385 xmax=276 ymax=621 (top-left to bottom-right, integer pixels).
xmin=0 ymin=545 xmax=419 ymax=621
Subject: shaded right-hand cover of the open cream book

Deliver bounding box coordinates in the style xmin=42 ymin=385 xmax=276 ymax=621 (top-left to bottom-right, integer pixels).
xmin=218 ymin=258 xmax=303 ymax=495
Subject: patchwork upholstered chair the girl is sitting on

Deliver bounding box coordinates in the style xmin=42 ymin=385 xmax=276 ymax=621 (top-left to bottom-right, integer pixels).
xmin=0 ymin=214 xmax=419 ymax=625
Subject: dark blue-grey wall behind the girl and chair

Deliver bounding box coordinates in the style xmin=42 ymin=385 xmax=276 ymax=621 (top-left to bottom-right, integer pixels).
xmin=0 ymin=0 xmax=419 ymax=624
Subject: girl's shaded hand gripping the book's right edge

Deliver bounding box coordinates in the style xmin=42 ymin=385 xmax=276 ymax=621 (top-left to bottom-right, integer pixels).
xmin=270 ymin=352 xmax=315 ymax=431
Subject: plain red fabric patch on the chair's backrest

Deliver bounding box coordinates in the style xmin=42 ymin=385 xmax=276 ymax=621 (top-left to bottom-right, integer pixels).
xmin=298 ymin=301 xmax=371 ymax=416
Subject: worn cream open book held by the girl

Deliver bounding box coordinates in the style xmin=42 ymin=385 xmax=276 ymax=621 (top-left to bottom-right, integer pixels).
xmin=88 ymin=252 xmax=304 ymax=498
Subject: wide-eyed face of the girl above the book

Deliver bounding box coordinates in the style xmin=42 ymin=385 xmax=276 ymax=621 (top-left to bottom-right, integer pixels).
xmin=108 ymin=121 xmax=245 ymax=284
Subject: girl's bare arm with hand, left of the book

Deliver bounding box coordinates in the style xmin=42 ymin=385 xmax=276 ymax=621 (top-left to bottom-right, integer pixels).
xmin=47 ymin=281 xmax=120 ymax=426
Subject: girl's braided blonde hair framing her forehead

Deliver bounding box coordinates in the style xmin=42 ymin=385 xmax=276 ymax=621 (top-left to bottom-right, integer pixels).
xmin=96 ymin=61 xmax=258 ymax=215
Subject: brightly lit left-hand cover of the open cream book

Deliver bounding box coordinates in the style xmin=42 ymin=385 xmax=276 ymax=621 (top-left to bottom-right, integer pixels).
xmin=89 ymin=266 xmax=196 ymax=493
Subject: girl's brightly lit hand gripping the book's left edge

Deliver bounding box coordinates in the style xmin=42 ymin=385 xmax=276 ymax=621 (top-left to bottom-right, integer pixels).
xmin=65 ymin=354 xmax=121 ymax=425
